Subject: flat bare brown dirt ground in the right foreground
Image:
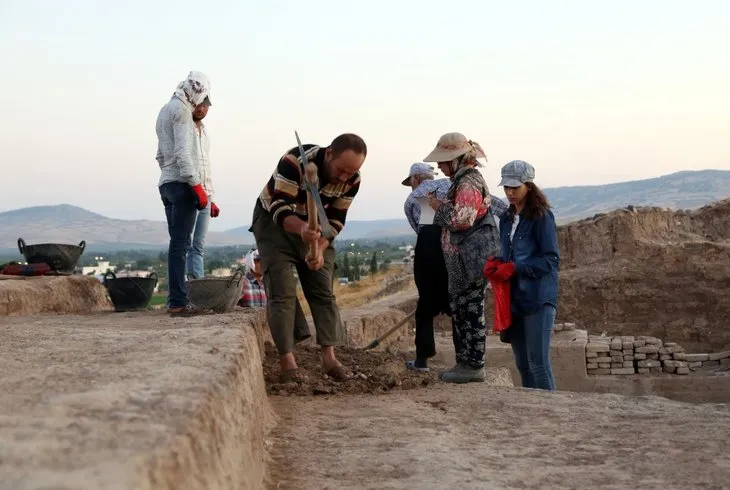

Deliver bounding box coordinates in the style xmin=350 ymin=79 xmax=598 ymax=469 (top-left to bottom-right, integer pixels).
xmin=270 ymin=384 xmax=730 ymax=490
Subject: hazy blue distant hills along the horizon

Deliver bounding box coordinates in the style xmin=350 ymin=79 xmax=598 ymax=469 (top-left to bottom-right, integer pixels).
xmin=0 ymin=170 xmax=730 ymax=251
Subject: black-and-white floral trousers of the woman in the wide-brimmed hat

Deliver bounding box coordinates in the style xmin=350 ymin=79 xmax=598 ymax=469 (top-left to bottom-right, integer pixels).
xmin=450 ymin=279 xmax=487 ymax=369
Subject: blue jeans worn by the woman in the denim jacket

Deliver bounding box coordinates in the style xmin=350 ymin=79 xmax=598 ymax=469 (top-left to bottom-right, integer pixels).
xmin=510 ymin=304 xmax=555 ymax=391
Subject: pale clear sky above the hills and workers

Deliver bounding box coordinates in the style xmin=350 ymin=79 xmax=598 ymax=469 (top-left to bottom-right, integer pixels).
xmin=0 ymin=0 xmax=730 ymax=230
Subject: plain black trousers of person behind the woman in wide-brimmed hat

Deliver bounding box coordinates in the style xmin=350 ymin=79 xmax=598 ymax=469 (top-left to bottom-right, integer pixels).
xmin=413 ymin=225 xmax=451 ymax=359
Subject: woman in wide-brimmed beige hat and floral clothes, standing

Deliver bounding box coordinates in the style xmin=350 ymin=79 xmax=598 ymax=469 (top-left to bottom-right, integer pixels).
xmin=424 ymin=133 xmax=499 ymax=383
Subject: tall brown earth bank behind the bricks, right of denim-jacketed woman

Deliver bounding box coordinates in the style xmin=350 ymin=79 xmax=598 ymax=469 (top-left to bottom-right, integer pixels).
xmin=558 ymin=199 xmax=730 ymax=350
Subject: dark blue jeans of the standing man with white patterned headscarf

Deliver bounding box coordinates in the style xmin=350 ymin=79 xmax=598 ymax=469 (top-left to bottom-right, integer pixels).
xmin=160 ymin=182 xmax=198 ymax=308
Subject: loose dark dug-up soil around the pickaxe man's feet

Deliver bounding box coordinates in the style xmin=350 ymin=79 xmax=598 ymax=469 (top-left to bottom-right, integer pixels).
xmin=264 ymin=343 xmax=513 ymax=396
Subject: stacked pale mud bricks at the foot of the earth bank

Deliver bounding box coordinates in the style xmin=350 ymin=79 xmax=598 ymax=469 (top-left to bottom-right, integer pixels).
xmin=586 ymin=335 xmax=730 ymax=375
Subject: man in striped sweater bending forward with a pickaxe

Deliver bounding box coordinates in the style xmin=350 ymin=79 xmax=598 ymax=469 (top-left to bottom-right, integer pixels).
xmin=251 ymin=133 xmax=367 ymax=383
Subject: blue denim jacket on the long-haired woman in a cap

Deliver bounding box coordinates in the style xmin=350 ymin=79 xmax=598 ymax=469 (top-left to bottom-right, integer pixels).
xmin=499 ymin=210 xmax=560 ymax=315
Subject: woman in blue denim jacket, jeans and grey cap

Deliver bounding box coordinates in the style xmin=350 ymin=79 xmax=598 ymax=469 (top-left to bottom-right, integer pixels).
xmin=499 ymin=160 xmax=560 ymax=391
